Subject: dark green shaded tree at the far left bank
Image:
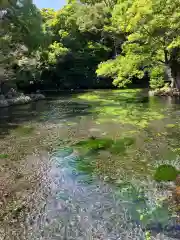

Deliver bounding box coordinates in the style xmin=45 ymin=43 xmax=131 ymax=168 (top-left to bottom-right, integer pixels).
xmin=0 ymin=0 xmax=45 ymax=90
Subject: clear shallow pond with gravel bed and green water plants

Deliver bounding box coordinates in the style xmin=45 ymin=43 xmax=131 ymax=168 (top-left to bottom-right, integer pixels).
xmin=0 ymin=89 xmax=180 ymax=240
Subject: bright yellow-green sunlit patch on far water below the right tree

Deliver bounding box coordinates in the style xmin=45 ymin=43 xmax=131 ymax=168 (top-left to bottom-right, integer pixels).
xmin=77 ymin=89 xmax=165 ymax=128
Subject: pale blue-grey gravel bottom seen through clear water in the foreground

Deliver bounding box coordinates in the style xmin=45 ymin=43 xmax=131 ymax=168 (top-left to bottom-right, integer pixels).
xmin=19 ymin=151 xmax=179 ymax=240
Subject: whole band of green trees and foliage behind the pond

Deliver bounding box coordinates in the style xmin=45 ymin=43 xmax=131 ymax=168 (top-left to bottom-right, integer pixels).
xmin=0 ymin=0 xmax=180 ymax=89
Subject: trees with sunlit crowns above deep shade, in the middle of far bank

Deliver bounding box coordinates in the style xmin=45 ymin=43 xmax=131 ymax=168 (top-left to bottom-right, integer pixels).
xmin=34 ymin=1 xmax=110 ymax=88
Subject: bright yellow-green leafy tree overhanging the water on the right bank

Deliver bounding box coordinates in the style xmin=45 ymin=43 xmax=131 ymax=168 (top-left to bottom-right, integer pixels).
xmin=97 ymin=0 xmax=180 ymax=89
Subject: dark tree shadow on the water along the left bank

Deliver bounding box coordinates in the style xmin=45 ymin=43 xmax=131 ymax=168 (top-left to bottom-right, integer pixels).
xmin=0 ymin=97 xmax=91 ymax=138
